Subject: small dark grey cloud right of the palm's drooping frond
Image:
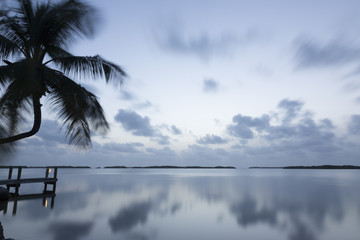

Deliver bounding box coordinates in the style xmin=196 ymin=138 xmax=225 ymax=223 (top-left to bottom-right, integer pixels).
xmin=115 ymin=109 xmax=156 ymax=137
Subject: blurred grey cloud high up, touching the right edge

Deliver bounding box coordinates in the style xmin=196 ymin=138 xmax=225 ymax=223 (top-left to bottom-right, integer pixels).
xmin=295 ymin=40 xmax=360 ymax=68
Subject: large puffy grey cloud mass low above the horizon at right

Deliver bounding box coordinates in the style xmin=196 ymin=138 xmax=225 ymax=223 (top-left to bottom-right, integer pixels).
xmin=227 ymin=99 xmax=346 ymax=161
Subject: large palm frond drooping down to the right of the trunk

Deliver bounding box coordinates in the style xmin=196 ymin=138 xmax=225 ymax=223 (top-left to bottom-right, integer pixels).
xmin=47 ymin=69 xmax=109 ymax=147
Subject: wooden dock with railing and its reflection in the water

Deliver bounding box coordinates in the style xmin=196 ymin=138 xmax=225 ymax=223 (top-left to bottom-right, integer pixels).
xmin=0 ymin=167 xmax=57 ymax=215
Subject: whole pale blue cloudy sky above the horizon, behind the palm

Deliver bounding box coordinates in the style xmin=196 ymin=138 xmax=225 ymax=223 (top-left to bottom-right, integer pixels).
xmin=0 ymin=0 xmax=360 ymax=168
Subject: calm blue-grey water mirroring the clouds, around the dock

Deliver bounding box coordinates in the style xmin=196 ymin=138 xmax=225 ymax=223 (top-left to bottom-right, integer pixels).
xmin=0 ymin=169 xmax=360 ymax=240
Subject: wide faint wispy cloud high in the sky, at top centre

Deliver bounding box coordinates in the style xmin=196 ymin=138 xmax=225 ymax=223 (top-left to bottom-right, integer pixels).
xmin=156 ymin=27 xmax=257 ymax=60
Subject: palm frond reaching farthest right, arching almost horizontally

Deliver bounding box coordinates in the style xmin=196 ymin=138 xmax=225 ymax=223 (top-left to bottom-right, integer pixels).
xmin=52 ymin=55 xmax=126 ymax=85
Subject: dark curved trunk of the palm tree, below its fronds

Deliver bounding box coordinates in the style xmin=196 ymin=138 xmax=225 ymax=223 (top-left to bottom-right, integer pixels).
xmin=0 ymin=96 xmax=42 ymax=144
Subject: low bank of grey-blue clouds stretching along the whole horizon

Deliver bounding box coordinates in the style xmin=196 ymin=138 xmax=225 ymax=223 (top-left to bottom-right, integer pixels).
xmin=4 ymin=99 xmax=360 ymax=166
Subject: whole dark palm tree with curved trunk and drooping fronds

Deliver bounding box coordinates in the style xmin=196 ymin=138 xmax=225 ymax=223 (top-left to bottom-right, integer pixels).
xmin=0 ymin=0 xmax=126 ymax=147
